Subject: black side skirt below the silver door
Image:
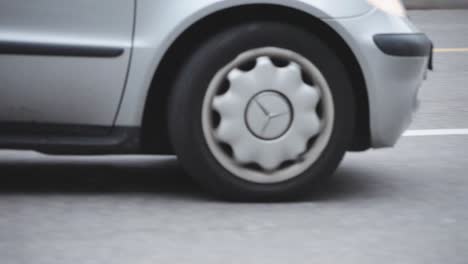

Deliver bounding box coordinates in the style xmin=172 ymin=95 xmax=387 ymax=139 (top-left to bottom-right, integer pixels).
xmin=0 ymin=123 xmax=141 ymax=155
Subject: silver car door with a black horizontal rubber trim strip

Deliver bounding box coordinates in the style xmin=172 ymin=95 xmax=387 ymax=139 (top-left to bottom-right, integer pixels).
xmin=0 ymin=0 xmax=135 ymax=130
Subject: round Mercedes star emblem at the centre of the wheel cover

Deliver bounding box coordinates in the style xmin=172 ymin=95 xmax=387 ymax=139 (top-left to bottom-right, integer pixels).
xmin=245 ymin=91 xmax=293 ymax=140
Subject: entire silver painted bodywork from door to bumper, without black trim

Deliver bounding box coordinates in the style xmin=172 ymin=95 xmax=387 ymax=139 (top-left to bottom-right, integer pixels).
xmin=0 ymin=0 xmax=428 ymax=152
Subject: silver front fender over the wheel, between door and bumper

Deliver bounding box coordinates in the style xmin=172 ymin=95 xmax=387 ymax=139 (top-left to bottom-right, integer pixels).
xmin=116 ymin=0 xmax=372 ymax=126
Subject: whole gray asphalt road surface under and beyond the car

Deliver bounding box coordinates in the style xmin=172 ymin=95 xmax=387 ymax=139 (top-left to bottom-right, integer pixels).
xmin=0 ymin=10 xmax=468 ymax=264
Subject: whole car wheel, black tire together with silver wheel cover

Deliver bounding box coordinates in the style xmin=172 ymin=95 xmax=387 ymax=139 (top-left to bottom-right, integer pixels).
xmin=169 ymin=22 xmax=354 ymax=201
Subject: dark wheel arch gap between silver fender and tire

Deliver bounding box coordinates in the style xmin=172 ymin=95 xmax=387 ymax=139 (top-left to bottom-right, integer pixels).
xmin=141 ymin=4 xmax=371 ymax=154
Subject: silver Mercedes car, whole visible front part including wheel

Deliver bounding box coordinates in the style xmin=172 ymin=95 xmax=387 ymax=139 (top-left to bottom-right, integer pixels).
xmin=0 ymin=0 xmax=432 ymax=201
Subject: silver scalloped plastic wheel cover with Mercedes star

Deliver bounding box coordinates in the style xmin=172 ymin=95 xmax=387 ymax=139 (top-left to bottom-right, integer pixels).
xmin=202 ymin=47 xmax=334 ymax=184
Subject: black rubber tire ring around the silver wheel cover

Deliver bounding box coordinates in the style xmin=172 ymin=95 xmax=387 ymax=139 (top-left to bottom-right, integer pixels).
xmin=168 ymin=22 xmax=355 ymax=201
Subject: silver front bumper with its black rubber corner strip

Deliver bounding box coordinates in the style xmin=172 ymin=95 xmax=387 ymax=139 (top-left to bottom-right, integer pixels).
xmin=327 ymin=10 xmax=432 ymax=148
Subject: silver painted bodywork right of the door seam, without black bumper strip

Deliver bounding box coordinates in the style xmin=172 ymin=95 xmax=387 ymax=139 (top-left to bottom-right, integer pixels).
xmin=117 ymin=0 xmax=427 ymax=147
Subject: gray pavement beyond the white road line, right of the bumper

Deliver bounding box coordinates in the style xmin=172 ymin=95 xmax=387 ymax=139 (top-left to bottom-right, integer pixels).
xmin=410 ymin=10 xmax=468 ymax=129
